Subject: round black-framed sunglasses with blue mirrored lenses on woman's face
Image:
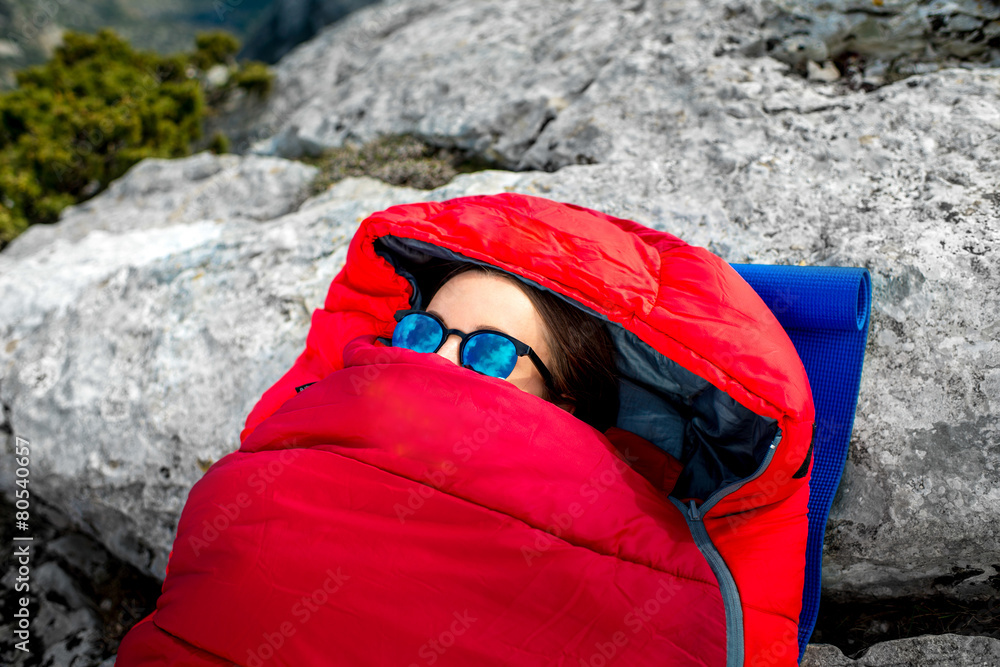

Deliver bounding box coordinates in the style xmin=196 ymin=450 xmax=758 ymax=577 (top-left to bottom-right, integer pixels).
xmin=392 ymin=310 xmax=552 ymax=390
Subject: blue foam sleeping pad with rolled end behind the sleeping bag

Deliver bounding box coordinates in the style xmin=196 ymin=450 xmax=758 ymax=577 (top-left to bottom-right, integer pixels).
xmin=732 ymin=264 xmax=871 ymax=662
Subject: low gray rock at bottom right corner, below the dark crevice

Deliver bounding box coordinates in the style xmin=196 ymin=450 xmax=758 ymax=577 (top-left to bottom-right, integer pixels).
xmin=801 ymin=635 xmax=1000 ymax=667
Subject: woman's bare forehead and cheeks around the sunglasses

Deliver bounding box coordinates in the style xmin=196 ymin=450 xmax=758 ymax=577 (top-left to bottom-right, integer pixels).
xmin=427 ymin=271 xmax=552 ymax=398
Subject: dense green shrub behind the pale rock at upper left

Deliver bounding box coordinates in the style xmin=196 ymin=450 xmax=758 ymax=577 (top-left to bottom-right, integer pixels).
xmin=0 ymin=25 xmax=271 ymax=249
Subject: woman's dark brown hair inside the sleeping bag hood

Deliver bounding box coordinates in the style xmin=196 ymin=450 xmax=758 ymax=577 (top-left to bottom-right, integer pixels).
xmin=439 ymin=262 xmax=618 ymax=433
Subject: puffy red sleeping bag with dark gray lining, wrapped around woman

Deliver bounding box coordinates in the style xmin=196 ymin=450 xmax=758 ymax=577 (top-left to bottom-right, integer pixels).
xmin=116 ymin=194 xmax=813 ymax=667
